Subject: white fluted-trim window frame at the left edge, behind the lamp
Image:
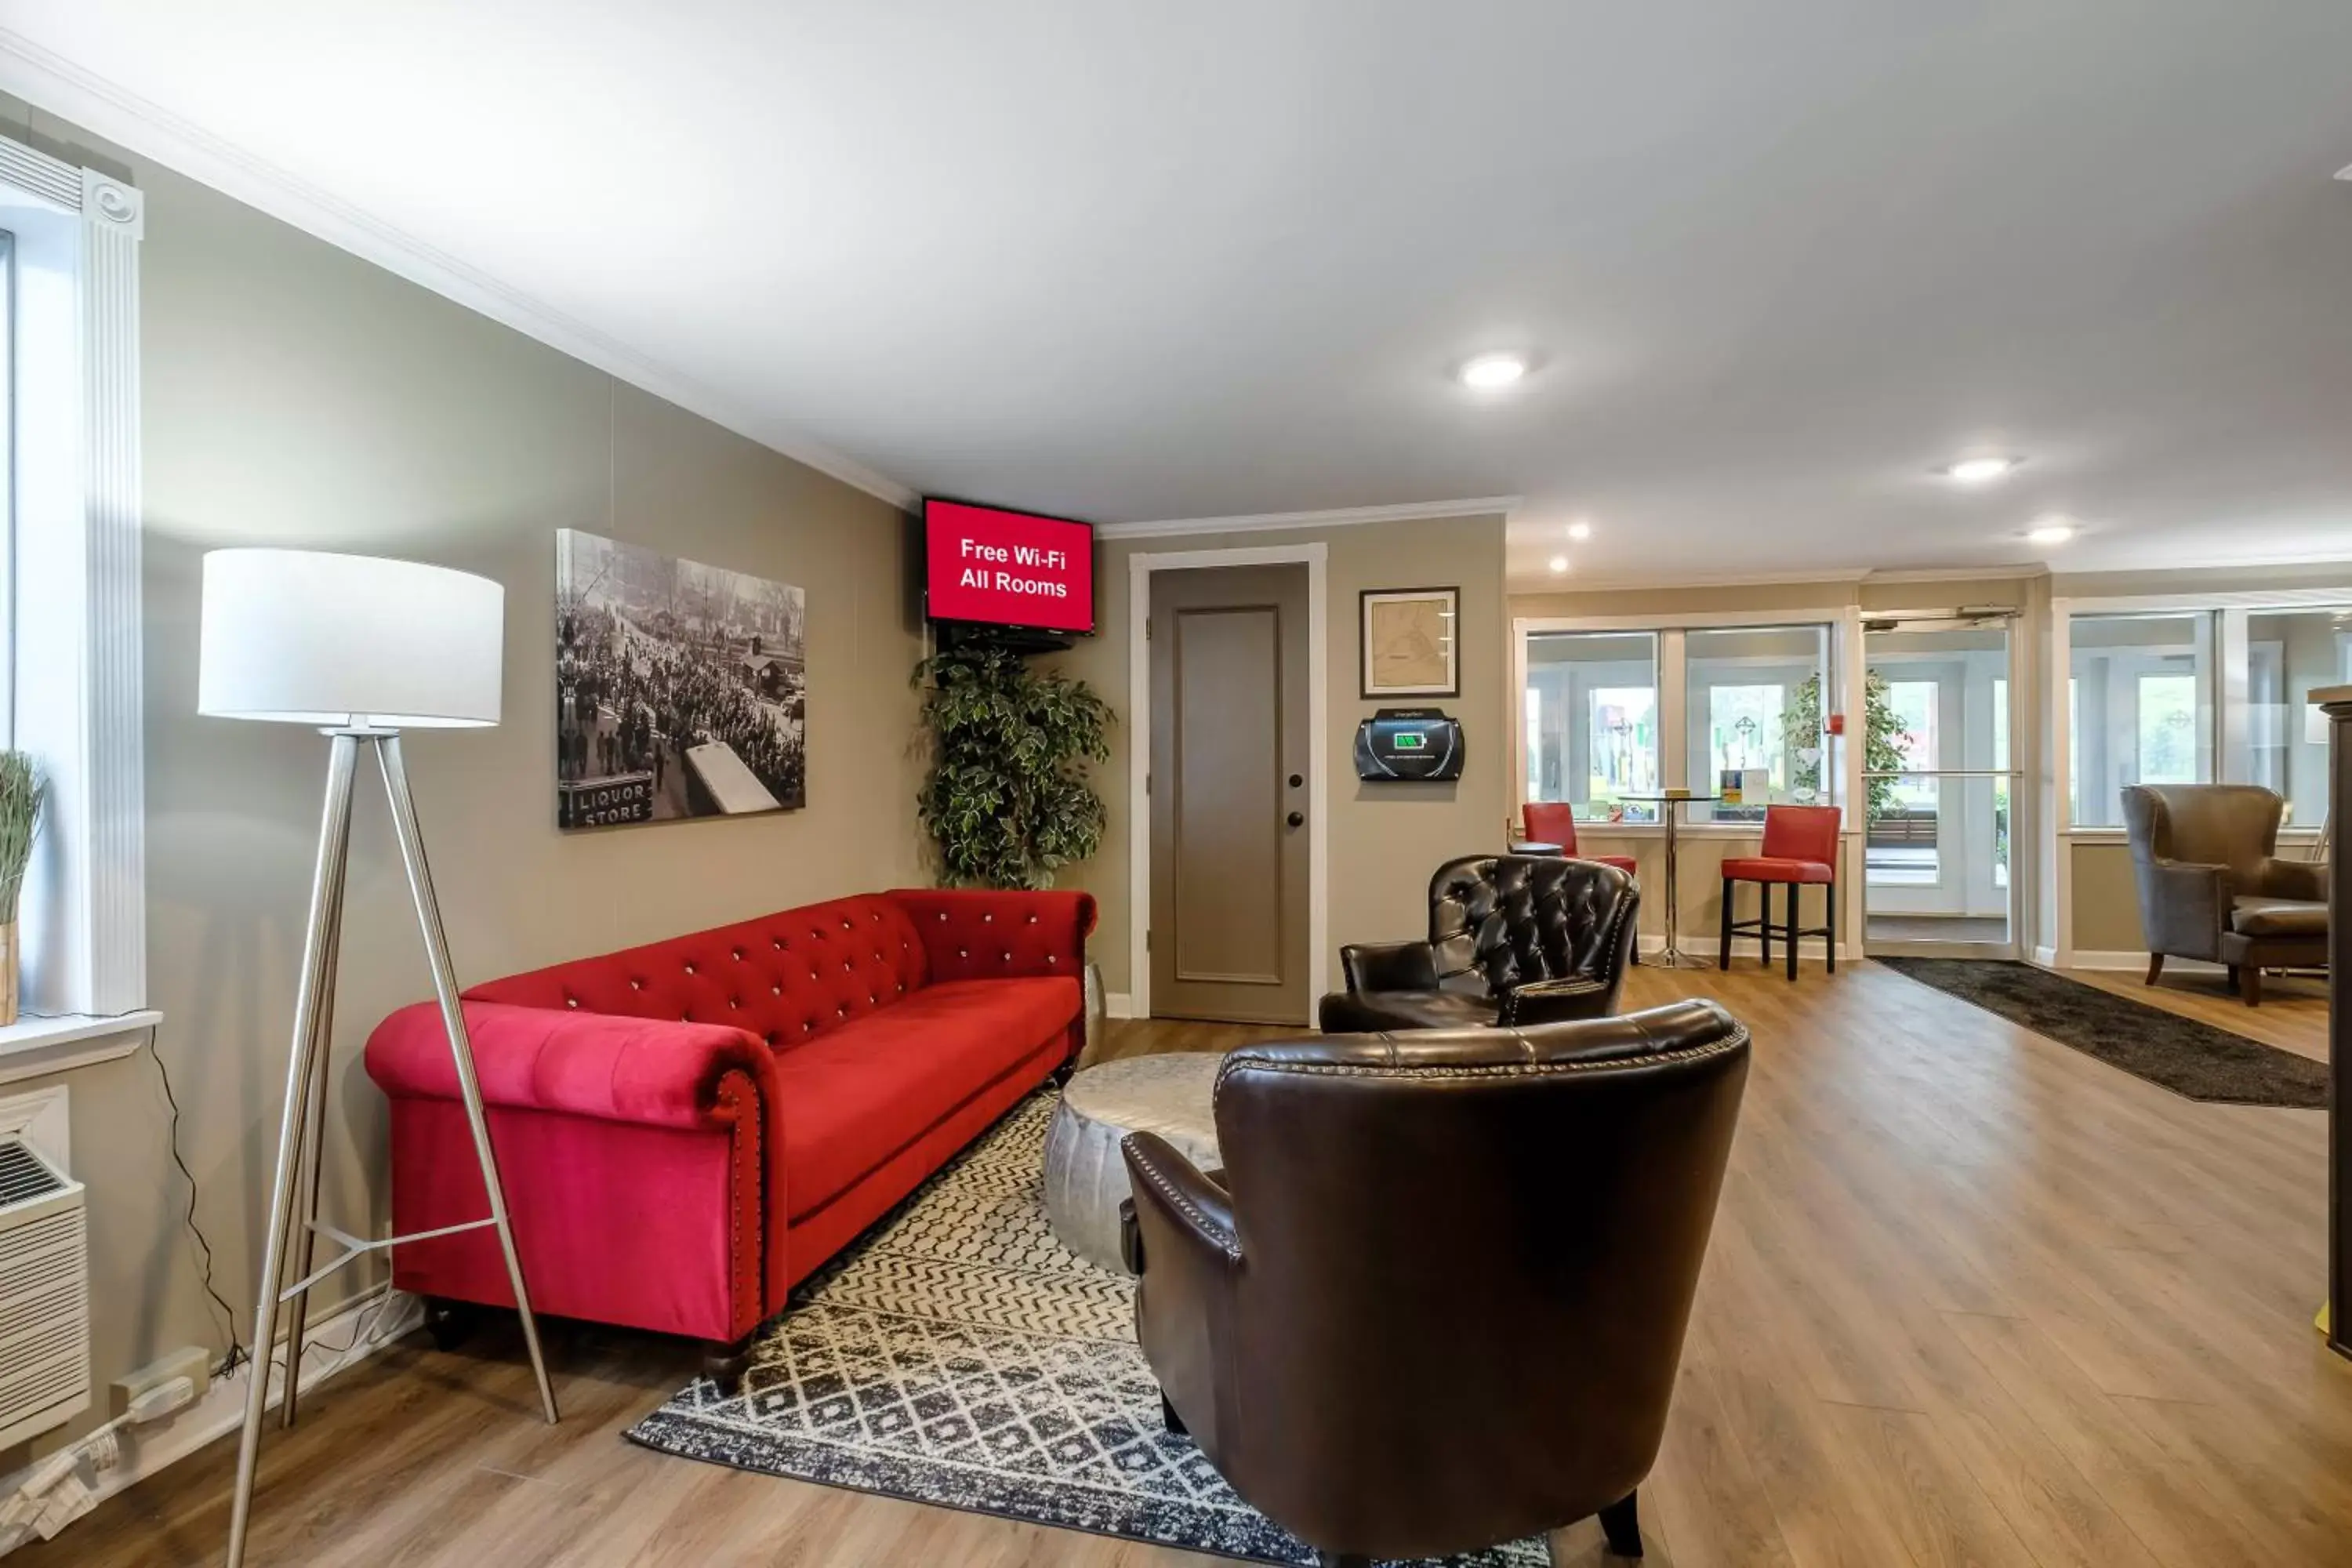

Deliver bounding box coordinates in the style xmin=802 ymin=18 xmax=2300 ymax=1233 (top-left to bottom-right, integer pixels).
xmin=0 ymin=139 xmax=155 ymax=1044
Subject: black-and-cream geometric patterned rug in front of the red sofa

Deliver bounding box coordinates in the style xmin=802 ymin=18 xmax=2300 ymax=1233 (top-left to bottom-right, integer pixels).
xmin=628 ymin=1091 xmax=1548 ymax=1568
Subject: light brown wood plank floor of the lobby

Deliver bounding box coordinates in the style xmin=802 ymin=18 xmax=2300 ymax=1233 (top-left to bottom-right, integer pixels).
xmin=41 ymin=964 xmax=2352 ymax=1568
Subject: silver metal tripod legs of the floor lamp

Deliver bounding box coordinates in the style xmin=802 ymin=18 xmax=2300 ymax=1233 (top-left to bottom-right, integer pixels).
xmin=226 ymin=727 xmax=555 ymax=1568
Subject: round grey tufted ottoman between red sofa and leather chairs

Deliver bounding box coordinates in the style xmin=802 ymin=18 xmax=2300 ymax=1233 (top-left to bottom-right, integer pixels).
xmin=1044 ymin=1051 xmax=1225 ymax=1274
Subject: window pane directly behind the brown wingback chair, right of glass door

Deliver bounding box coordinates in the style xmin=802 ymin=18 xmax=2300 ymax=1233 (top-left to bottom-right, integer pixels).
xmin=2067 ymin=612 xmax=2218 ymax=827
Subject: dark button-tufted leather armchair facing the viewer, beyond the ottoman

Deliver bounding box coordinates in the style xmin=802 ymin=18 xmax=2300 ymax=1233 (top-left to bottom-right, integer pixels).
xmin=1317 ymin=855 xmax=1642 ymax=1034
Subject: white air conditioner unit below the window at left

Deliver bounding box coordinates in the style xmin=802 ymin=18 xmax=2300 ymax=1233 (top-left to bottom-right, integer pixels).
xmin=0 ymin=1131 xmax=89 ymax=1448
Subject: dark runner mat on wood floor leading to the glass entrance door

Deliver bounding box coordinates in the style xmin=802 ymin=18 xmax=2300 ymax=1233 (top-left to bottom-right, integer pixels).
xmin=1875 ymin=959 xmax=2328 ymax=1109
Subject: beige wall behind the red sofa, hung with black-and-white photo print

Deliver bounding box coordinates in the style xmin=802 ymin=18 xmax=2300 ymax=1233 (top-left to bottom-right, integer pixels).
xmin=0 ymin=106 xmax=922 ymax=1457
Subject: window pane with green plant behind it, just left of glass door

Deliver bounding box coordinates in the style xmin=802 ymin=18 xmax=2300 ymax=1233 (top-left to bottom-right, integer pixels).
xmin=1682 ymin=626 xmax=1835 ymax=822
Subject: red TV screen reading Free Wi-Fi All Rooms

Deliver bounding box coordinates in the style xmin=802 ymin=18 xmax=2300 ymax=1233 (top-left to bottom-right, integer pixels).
xmin=922 ymin=501 xmax=1094 ymax=633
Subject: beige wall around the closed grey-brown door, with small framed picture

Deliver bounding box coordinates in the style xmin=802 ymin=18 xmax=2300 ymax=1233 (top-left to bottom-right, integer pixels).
xmin=1058 ymin=517 xmax=1510 ymax=992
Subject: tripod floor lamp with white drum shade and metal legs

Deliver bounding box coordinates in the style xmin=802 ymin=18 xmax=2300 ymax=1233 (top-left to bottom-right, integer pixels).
xmin=195 ymin=550 xmax=555 ymax=1568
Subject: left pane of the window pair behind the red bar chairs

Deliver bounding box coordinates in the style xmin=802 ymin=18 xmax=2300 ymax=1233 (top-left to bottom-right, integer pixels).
xmin=1522 ymin=633 xmax=1661 ymax=822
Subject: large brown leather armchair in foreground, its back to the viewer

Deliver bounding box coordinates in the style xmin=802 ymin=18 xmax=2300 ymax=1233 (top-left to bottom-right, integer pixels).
xmin=1122 ymin=1001 xmax=1748 ymax=1563
